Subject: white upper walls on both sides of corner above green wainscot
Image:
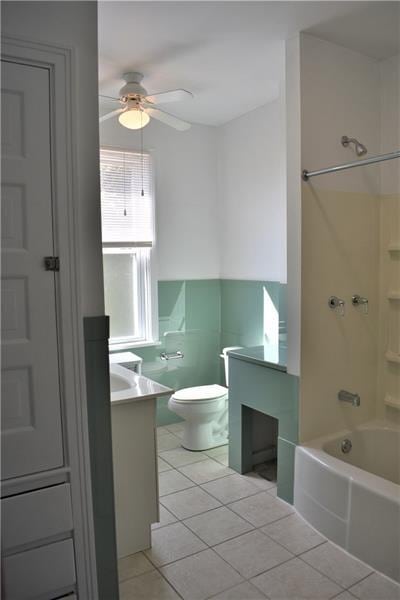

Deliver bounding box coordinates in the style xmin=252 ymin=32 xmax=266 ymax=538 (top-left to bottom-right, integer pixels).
xmin=100 ymin=97 xmax=286 ymax=282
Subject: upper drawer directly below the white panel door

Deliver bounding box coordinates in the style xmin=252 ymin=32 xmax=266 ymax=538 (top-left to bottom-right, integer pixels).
xmin=1 ymin=483 xmax=73 ymax=552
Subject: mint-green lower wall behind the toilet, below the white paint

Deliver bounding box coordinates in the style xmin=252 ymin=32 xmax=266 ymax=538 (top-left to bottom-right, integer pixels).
xmin=112 ymin=279 xmax=286 ymax=425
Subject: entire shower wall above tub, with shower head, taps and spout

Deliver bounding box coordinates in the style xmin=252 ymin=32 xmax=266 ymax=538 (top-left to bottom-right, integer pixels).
xmin=288 ymin=34 xmax=400 ymax=441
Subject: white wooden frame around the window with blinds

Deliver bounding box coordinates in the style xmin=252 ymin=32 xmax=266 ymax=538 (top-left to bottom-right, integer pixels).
xmin=100 ymin=144 xmax=161 ymax=351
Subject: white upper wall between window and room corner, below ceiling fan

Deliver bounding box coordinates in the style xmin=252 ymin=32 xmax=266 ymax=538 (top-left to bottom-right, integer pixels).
xmin=100 ymin=119 xmax=220 ymax=280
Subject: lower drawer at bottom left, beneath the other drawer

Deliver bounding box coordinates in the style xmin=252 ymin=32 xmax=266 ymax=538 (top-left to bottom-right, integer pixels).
xmin=3 ymin=539 xmax=76 ymax=600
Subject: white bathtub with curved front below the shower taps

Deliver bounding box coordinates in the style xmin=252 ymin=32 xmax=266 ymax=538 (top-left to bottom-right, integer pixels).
xmin=294 ymin=421 xmax=400 ymax=581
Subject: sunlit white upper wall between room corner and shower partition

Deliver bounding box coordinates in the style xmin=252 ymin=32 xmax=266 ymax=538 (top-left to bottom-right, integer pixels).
xmin=218 ymin=93 xmax=286 ymax=282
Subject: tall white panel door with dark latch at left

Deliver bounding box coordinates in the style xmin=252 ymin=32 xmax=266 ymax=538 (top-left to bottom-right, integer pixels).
xmin=1 ymin=61 xmax=63 ymax=479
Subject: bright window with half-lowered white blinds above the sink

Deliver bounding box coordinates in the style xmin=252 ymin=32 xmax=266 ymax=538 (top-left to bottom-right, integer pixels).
xmin=100 ymin=148 xmax=155 ymax=344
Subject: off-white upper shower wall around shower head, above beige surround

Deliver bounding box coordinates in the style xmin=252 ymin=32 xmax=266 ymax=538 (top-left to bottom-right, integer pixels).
xmin=300 ymin=34 xmax=380 ymax=194
